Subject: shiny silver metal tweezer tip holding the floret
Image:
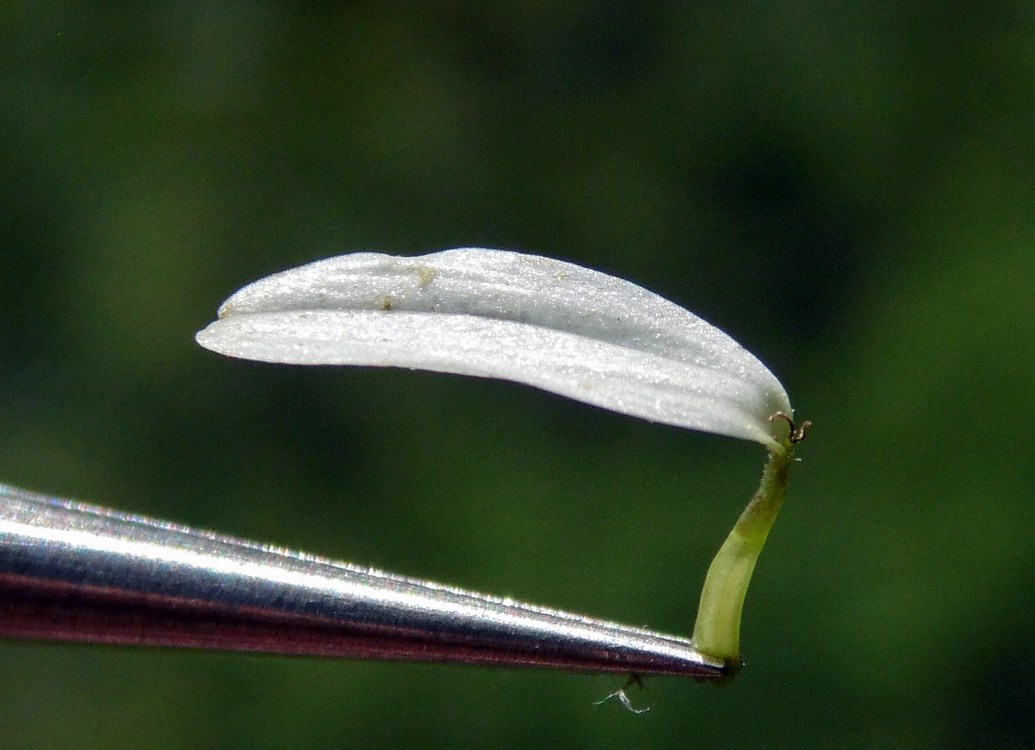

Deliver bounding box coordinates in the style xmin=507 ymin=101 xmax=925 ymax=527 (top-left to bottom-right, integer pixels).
xmin=0 ymin=484 xmax=729 ymax=679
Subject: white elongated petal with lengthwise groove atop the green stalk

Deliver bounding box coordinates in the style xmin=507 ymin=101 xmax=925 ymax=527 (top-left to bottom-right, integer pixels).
xmin=198 ymin=248 xmax=791 ymax=446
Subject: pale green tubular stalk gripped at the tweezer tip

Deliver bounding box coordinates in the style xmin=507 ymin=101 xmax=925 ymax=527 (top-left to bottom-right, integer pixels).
xmin=693 ymin=443 xmax=794 ymax=676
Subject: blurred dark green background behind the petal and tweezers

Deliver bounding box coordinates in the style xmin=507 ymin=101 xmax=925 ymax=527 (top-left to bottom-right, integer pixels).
xmin=0 ymin=1 xmax=1035 ymax=750
